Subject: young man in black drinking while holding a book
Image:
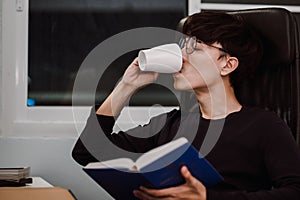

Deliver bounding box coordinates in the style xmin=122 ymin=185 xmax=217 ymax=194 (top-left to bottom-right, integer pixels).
xmin=73 ymin=12 xmax=300 ymax=200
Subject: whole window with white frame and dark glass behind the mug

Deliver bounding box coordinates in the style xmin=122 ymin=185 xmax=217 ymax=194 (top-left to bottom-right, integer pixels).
xmin=2 ymin=0 xmax=198 ymax=137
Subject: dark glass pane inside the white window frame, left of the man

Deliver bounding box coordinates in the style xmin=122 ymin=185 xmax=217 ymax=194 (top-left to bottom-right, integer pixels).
xmin=28 ymin=0 xmax=186 ymax=106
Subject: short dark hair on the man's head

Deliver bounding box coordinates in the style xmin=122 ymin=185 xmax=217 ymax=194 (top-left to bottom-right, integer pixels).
xmin=182 ymin=11 xmax=263 ymax=88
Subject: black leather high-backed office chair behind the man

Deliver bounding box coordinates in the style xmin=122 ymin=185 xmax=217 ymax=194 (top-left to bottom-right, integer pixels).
xmin=178 ymin=8 xmax=300 ymax=145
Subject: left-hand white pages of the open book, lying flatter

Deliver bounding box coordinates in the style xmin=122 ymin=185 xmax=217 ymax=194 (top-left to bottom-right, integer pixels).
xmin=84 ymin=158 xmax=135 ymax=169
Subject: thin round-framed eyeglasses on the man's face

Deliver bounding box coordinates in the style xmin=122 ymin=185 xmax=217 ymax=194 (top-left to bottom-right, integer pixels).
xmin=178 ymin=36 xmax=230 ymax=54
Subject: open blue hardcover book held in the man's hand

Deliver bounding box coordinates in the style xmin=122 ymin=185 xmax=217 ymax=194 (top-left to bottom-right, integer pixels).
xmin=83 ymin=137 xmax=223 ymax=199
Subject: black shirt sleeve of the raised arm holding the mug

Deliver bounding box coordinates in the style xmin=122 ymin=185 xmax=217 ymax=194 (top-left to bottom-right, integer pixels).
xmin=72 ymin=107 xmax=177 ymax=165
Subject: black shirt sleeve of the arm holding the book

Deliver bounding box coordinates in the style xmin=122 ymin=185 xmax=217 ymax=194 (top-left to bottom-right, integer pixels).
xmin=207 ymin=113 xmax=300 ymax=200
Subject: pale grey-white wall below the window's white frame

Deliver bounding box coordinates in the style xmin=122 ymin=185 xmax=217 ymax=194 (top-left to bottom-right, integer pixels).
xmin=0 ymin=0 xmax=112 ymax=200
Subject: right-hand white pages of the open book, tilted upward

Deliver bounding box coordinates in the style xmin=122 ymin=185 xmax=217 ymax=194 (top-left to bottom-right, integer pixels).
xmin=136 ymin=137 xmax=188 ymax=169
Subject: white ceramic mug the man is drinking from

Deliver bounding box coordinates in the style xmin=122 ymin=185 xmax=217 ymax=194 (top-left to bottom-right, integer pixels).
xmin=138 ymin=43 xmax=182 ymax=73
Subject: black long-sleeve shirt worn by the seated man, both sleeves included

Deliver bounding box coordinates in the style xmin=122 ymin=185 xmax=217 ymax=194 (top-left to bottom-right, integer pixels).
xmin=73 ymin=107 xmax=300 ymax=200
